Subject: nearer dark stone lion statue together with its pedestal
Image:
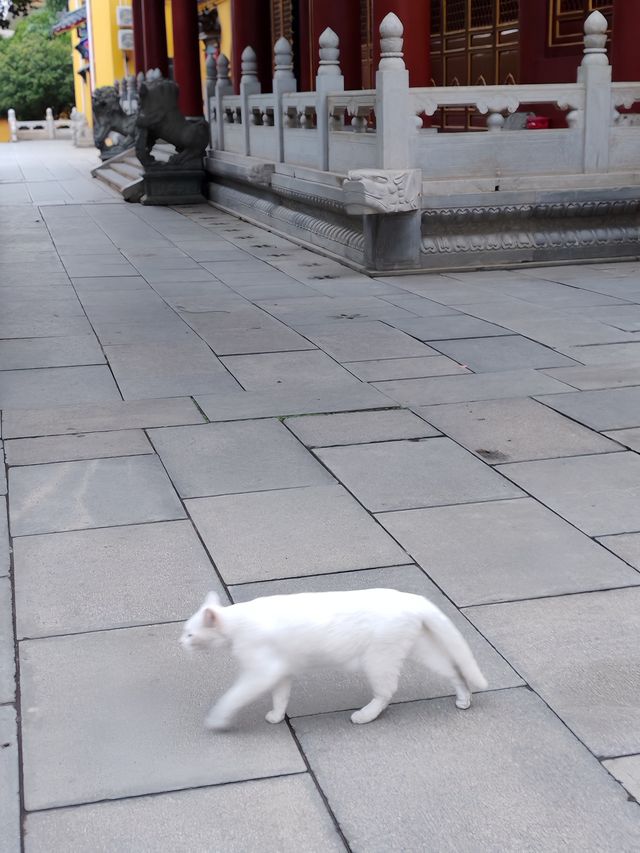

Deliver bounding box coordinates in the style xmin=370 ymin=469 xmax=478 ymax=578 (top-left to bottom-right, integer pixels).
xmin=136 ymin=78 xmax=209 ymax=204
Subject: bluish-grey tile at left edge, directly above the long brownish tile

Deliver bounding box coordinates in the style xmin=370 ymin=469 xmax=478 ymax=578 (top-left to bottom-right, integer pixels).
xmin=0 ymin=366 xmax=121 ymax=409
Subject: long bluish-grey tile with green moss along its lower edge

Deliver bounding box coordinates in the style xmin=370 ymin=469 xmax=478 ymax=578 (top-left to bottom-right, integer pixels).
xmin=196 ymin=384 xmax=393 ymax=421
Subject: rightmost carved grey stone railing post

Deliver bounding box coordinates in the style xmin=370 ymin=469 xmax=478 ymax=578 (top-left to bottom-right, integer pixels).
xmin=578 ymin=11 xmax=612 ymax=172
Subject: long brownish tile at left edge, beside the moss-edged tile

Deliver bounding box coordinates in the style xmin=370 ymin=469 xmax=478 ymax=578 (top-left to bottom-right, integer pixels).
xmin=2 ymin=397 xmax=204 ymax=438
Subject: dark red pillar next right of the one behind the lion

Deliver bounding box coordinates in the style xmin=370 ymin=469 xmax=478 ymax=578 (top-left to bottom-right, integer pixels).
xmin=231 ymin=0 xmax=273 ymax=93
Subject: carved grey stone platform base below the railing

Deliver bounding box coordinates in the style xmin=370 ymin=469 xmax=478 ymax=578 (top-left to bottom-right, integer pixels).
xmin=205 ymin=152 xmax=640 ymax=275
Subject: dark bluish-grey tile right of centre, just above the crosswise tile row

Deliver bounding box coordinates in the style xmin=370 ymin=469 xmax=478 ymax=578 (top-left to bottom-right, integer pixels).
xmin=436 ymin=335 xmax=575 ymax=378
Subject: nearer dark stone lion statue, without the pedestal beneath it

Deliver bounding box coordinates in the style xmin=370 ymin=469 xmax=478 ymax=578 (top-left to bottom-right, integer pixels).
xmin=136 ymin=78 xmax=209 ymax=169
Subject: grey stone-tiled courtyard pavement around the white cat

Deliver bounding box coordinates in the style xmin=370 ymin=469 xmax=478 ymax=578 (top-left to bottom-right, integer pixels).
xmin=0 ymin=143 xmax=640 ymax=853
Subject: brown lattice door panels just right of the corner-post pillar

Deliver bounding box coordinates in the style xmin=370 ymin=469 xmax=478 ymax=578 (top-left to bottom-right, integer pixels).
xmin=431 ymin=0 xmax=520 ymax=130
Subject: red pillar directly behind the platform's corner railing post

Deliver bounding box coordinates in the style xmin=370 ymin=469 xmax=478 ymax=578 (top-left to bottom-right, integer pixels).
xmin=372 ymin=0 xmax=431 ymax=86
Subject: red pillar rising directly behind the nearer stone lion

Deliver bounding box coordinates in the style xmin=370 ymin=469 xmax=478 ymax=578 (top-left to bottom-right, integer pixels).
xmin=171 ymin=0 xmax=202 ymax=116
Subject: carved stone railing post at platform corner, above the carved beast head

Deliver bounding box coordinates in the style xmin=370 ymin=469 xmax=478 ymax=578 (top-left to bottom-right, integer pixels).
xmin=376 ymin=12 xmax=411 ymax=169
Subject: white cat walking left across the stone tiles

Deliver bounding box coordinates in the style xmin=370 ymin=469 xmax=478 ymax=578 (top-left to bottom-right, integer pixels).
xmin=180 ymin=589 xmax=487 ymax=729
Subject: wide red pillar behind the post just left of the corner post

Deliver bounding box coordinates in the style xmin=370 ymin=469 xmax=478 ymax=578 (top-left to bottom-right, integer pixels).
xmin=298 ymin=0 xmax=362 ymax=92
